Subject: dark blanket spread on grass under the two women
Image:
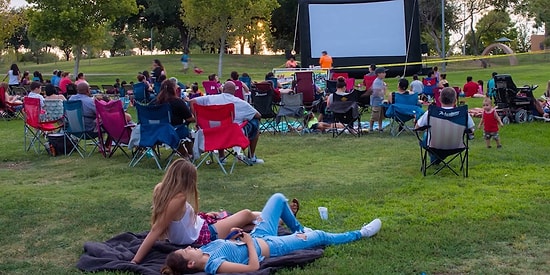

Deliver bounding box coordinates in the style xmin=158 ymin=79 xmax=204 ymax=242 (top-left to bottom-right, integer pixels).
xmin=76 ymin=232 xmax=323 ymax=275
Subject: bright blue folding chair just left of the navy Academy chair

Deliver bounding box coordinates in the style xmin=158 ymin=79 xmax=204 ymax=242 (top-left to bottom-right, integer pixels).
xmin=385 ymin=93 xmax=424 ymax=137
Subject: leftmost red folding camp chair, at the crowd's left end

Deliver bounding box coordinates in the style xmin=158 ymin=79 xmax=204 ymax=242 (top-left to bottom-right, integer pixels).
xmin=23 ymin=96 xmax=63 ymax=153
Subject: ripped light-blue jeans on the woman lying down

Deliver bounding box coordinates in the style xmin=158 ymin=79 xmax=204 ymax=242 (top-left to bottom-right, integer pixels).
xmin=251 ymin=193 xmax=361 ymax=257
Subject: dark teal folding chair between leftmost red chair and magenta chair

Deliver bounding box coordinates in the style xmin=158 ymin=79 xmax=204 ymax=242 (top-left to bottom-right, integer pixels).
xmin=63 ymin=100 xmax=98 ymax=158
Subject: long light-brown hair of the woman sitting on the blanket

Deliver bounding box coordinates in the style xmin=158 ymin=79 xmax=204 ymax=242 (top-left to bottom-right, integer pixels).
xmin=151 ymin=159 xmax=199 ymax=237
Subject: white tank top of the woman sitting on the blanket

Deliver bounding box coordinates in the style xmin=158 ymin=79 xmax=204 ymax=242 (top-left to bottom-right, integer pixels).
xmin=168 ymin=202 xmax=204 ymax=244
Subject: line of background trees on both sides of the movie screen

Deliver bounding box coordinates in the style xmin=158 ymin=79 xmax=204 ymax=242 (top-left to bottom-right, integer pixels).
xmin=0 ymin=0 xmax=550 ymax=71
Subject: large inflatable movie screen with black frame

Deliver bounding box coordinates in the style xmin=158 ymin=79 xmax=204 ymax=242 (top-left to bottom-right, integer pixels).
xmin=298 ymin=0 xmax=422 ymax=75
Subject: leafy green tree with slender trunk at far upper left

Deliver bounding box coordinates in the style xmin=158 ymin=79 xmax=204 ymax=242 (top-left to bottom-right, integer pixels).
xmin=28 ymin=0 xmax=138 ymax=75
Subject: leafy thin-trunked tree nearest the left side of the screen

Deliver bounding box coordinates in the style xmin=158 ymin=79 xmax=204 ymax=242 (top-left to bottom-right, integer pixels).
xmin=182 ymin=0 xmax=278 ymax=76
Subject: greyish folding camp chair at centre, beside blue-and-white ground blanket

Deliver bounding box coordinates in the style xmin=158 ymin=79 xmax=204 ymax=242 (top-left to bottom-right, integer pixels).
xmin=275 ymin=93 xmax=305 ymax=133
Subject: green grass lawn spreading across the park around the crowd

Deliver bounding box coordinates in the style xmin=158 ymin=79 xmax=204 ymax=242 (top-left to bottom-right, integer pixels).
xmin=0 ymin=52 xmax=550 ymax=274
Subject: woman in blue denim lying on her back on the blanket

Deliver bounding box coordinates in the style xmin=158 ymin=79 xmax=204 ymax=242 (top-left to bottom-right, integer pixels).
xmin=161 ymin=193 xmax=382 ymax=274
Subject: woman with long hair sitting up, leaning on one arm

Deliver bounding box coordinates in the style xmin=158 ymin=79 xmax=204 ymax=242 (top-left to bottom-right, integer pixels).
xmin=132 ymin=159 xmax=299 ymax=264
